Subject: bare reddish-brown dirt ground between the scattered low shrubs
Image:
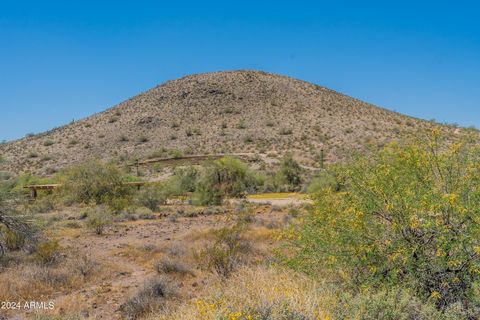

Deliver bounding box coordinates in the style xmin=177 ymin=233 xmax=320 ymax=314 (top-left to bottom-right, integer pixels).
xmin=0 ymin=199 xmax=292 ymax=320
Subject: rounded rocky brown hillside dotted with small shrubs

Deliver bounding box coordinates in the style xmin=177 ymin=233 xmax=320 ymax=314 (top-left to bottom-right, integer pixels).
xmin=0 ymin=71 xmax=450 ymax=174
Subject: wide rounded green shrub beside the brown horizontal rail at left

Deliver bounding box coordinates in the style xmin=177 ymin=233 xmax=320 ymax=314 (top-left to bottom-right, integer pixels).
xmin=60 ymin=161 xmax=132 ymax=210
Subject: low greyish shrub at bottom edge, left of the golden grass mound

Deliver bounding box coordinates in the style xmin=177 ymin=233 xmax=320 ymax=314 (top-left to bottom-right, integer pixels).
xmin=120 ymin=279 xmax=175 ymax=319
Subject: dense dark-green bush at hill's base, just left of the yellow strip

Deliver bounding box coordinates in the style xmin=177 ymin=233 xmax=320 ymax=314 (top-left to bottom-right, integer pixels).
xmin=195 ymin=157 xmax=258 ymax=205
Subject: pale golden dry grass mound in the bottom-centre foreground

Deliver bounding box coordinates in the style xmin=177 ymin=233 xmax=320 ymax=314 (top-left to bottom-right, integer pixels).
xmin=152 ymin=266 xmax=336 ymax=320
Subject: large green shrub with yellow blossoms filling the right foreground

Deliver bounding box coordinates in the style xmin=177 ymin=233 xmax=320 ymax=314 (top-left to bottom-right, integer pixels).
xmin=292 ymin=133 xmax=480 ymax=309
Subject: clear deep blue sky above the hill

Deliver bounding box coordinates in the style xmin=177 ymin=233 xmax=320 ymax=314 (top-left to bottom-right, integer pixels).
xmin=0 ymin=0 xmax=480 ymax=140
